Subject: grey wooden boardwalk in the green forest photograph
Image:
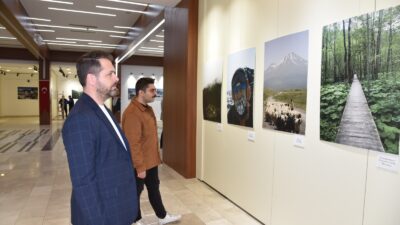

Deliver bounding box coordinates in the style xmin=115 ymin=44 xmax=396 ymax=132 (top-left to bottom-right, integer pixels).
xmin=336 ymin=75 xmax=384 ymax=152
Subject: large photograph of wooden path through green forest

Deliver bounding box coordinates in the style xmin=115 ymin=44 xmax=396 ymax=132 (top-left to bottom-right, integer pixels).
xmin=320 ymin=6 xmax=400 ymax=154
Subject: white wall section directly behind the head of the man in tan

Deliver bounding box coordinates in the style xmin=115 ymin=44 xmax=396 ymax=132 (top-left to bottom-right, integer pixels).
xmin=121 ymin=65 xmax=164 ymax=120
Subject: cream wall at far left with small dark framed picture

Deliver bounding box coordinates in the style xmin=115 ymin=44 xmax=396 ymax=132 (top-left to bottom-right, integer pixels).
xmin=0 ymin=73 xmax=39 ymax=116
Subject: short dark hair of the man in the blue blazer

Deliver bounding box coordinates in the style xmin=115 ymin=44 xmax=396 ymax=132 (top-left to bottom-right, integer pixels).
xmin=76 ymin=51 xmax=114 ymax=87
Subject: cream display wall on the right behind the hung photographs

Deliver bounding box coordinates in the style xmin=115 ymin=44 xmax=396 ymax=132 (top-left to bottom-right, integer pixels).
xmin=197 ymin=0 xmax=400 ymax=225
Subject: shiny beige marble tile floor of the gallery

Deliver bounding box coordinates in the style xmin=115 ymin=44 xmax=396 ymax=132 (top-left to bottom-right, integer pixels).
xmin=0 ymin=117 xmax=260 ymax=225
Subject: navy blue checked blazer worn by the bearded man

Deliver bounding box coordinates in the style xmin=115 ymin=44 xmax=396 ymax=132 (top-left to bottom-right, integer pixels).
xmin=62 ymin=93 xmax=138 ymax=225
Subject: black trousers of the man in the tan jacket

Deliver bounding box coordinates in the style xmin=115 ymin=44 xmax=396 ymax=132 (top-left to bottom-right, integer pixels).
xmin=135 ymin=166 xmax=167 ymax=222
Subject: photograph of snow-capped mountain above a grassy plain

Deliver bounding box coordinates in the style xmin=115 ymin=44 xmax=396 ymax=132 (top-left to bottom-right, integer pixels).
xmin=263 ymin=31 xmax=308 ymax=135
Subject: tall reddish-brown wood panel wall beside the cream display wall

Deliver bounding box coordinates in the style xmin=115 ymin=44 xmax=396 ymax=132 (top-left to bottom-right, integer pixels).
xmin=163 ymin=0 xmax=198 ymax=178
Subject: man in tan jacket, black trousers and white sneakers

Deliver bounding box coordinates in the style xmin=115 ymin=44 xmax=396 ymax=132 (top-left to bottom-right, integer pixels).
xmin=122 ymin=77 xmax=181 ymax=224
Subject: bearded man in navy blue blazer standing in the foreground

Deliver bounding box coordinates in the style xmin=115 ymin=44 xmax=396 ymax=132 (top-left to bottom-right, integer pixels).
xmin=62 ymin=51 xmax=138 ymax=225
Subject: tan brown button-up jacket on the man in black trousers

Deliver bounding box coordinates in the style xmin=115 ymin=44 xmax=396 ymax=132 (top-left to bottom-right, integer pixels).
xmin=122 ymin=98 xmax=161 ymax=173
